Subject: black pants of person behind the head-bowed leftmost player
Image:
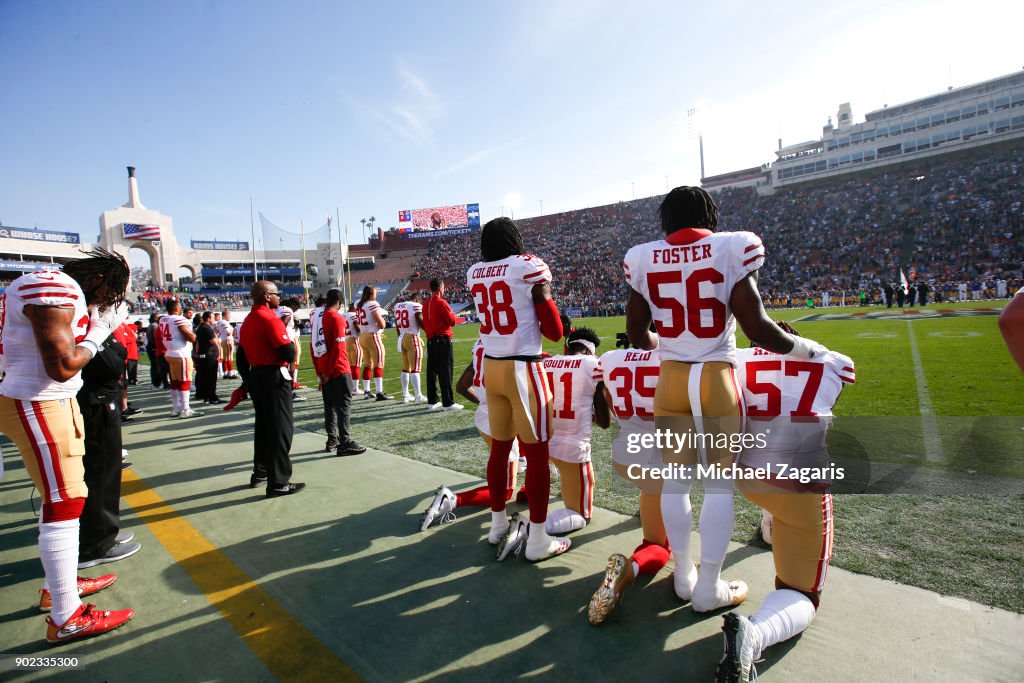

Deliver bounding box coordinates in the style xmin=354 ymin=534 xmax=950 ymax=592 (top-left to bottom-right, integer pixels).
xmin=78 ymin=398 xmax=121 ymax=559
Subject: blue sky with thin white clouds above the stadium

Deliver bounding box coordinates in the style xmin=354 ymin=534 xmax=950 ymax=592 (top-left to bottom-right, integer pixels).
xmin=0 ymin=0 xmax=1024 ymax=253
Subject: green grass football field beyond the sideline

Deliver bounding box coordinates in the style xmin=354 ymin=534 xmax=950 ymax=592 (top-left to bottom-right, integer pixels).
xmin=205 ymin=302 xmax=1024 ymax=612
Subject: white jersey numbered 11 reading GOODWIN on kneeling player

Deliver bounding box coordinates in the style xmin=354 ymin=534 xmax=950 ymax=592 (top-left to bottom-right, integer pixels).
xmin=544 ymin=355 xmax=602 ymax=462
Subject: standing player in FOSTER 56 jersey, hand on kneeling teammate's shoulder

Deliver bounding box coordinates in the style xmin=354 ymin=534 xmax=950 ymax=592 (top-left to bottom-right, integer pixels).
xmin=624 ymin=186 xmax=826 ymax=612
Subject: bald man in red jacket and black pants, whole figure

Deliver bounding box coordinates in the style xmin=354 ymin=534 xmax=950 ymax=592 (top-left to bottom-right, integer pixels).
xmin=238 ymin=280 xmax=306 ymax=498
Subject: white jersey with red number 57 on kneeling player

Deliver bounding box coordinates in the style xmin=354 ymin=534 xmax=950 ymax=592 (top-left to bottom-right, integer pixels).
xmin=736 ymin=348 xmax=856 ymax=467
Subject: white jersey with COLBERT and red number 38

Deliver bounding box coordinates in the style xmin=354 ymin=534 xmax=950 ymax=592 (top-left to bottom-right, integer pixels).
xmin=466 ymin=254 xmax=551 ymax=358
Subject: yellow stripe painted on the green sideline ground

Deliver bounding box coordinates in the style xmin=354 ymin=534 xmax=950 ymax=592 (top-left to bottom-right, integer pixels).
xmin=121 ymin=470 xmax=362 ymax=681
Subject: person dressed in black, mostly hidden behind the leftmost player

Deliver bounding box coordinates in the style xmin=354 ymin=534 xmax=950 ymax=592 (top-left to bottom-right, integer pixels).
xmin=78 ymin=335 xmax=142 ymax=569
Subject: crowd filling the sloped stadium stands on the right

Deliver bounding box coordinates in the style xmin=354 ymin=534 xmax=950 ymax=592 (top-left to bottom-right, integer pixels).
xmin=403 ymin=143 xmax=1024 ymax=314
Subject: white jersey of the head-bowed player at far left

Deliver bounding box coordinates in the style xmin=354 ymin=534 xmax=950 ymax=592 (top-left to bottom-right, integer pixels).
xmin=0 ymin=270 xmax=89 ymax=400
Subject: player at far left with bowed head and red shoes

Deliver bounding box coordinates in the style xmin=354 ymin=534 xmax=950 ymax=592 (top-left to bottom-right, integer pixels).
xmin=0 ymin=249 xmax=135 ymax=643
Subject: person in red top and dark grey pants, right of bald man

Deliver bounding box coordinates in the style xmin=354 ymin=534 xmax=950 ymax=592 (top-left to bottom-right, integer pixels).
xmin=313 ymin=289 xmax=367 ymax=456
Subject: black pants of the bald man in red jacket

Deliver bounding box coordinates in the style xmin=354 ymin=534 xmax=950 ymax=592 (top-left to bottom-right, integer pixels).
xmin=249 ymin=366 xmax=294 ymax=487
